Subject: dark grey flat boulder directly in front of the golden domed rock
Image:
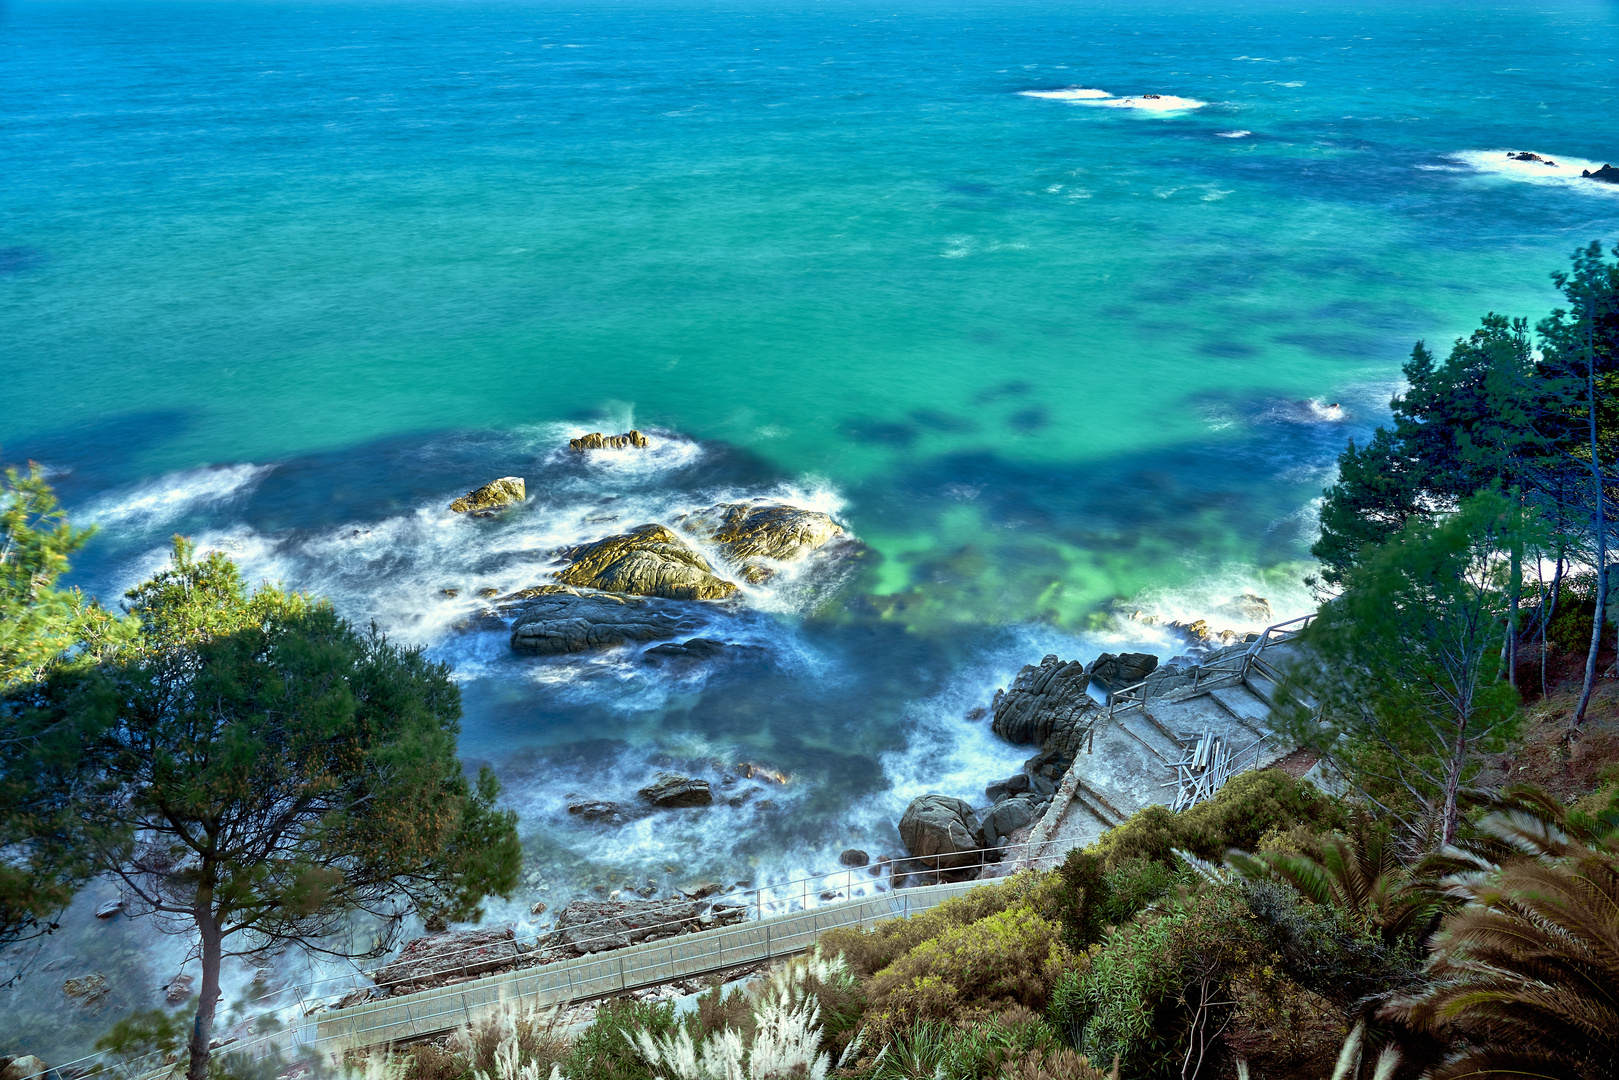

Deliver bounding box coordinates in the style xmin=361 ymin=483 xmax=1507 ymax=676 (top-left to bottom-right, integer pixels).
xmin=512 ymin=586 xmax=696 ymax=656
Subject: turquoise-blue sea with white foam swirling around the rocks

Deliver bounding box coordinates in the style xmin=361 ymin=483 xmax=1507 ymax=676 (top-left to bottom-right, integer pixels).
xmin=0 ymin=0 xmax=1619 ymax=1064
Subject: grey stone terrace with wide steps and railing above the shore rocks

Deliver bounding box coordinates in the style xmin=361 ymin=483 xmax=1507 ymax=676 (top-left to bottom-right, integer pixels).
xmin=1017 ymin=619 xmax=1308 ymax=868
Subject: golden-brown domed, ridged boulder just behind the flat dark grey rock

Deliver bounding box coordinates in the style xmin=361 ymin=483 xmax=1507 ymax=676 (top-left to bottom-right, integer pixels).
xmin=555 ymin=525 xmax=737 ymax=601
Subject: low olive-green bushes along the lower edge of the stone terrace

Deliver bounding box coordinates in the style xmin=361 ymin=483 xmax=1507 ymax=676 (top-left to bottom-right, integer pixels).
xmin=1094 ymin=769 xmax=1345 ymax=871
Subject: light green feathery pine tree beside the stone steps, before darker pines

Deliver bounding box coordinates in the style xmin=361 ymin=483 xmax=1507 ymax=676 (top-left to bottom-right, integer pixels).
xmin=1275 ymin=492 xmax=1533 ymax=847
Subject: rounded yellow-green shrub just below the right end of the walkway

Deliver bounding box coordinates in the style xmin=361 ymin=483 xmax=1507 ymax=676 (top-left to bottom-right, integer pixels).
xmin=866 ymin=907 xmax=1072 ymax=1041
